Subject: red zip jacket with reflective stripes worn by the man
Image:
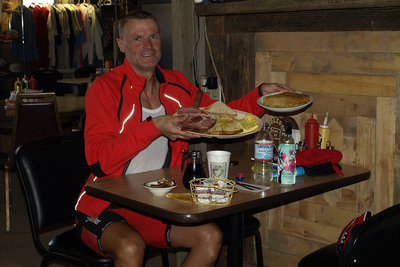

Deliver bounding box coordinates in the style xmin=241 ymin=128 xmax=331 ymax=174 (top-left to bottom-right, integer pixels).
xmin=77 ymin=60 xmax=264 ymax=218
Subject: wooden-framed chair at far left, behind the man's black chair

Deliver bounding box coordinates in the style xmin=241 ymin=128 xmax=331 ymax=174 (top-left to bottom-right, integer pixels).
xmin=3 ymin=93 xmax=61 ymax=232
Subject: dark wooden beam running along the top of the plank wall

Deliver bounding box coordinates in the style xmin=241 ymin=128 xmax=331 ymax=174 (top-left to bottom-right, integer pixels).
xmin=225 ymin=7 xmax=400 ymax=32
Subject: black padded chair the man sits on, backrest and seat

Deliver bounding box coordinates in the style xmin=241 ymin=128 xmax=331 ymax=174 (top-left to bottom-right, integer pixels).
xmin=15 ymin=135 xmax=168 ymax=266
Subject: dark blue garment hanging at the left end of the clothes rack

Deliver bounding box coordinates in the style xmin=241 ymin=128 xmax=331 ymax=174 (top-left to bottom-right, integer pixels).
xmin=11 ymin=6 xmax=38 ymax=62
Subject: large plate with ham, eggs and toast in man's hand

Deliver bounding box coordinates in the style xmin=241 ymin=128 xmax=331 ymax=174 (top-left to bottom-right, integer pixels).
xmin=177 ymin=101 xmax=263 ymax=139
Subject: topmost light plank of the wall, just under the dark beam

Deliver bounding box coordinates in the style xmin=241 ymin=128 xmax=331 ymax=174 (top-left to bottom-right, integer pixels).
xmin=254 ymin=31 xmax=400 ymax=53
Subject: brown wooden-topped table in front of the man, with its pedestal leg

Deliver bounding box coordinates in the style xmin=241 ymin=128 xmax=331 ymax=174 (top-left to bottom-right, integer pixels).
xmin=86 ymin=159 xmax=370 ymax=266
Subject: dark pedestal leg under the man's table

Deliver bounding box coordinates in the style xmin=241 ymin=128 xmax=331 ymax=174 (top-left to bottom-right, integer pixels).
xmin=227 ymin=213 xmax=244 ymax=267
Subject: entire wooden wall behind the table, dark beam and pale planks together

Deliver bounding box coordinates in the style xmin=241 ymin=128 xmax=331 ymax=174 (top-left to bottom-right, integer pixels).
xmin=190 ymin=0 xmax=400 ymax=267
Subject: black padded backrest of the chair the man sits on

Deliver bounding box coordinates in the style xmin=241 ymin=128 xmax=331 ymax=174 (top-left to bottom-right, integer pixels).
xmin=15 ymin=135 xmax=90 ymax=251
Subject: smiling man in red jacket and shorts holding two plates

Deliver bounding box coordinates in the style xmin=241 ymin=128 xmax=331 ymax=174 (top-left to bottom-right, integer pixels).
xmin=76 ymin=11 xmax=291 ymax=266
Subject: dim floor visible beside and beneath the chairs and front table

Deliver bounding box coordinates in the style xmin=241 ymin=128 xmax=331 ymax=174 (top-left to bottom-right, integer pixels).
xmin=0 ymin=171 xmax=255 ymax=267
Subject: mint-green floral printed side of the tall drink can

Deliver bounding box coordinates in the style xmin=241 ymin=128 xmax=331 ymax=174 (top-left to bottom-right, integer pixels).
xmin=278 ymin=144 xmax=297 ymax=184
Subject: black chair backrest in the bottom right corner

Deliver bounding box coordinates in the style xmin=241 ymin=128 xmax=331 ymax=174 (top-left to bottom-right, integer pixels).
xmin=339 ymin=204 xmax=400 ymax=267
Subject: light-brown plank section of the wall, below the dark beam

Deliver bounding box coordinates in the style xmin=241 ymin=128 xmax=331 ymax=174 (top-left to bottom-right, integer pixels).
xmin=250 ymin=31 xmax=400 ymax=267
